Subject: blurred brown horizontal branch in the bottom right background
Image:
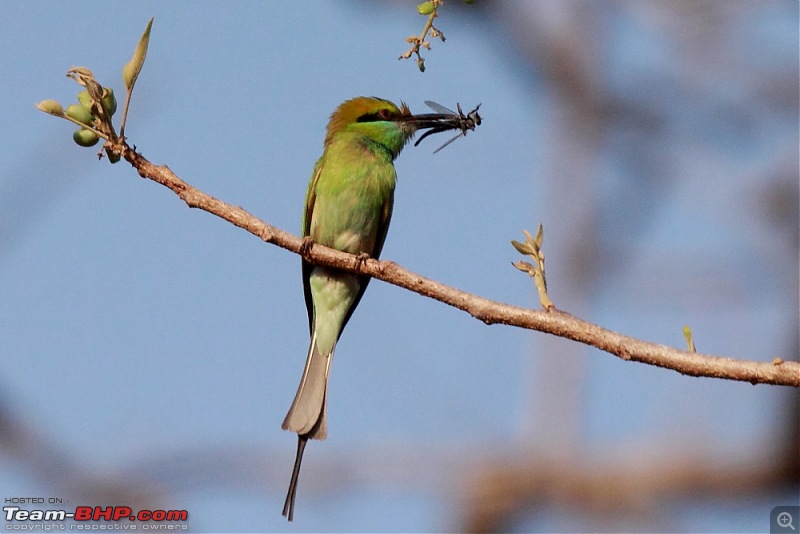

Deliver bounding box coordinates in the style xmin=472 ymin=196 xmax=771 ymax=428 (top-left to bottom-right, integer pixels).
xmin=457 ymin=447 xmax=798 ymax=532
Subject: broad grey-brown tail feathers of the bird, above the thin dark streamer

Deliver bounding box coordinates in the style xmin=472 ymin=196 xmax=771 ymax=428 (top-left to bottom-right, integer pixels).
xmin=281 ymin=333 xmax=333 ymax=439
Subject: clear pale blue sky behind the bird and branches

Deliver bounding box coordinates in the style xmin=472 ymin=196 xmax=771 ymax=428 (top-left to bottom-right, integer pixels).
xmin=0 ymin=2 xmax=797 ymax=531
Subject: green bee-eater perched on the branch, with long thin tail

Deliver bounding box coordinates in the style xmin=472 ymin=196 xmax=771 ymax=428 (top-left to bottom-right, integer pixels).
xmin=282 ymin=97 xmax=474 ymax=521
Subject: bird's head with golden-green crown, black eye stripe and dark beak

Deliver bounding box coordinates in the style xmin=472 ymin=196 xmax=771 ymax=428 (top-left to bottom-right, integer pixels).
xmin=325 ymin=96 xmax=454 ymax=158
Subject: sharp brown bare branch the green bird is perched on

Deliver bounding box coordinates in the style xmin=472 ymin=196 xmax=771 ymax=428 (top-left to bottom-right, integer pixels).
xmin=114 ymin=139 xmax=800 ymax=387
